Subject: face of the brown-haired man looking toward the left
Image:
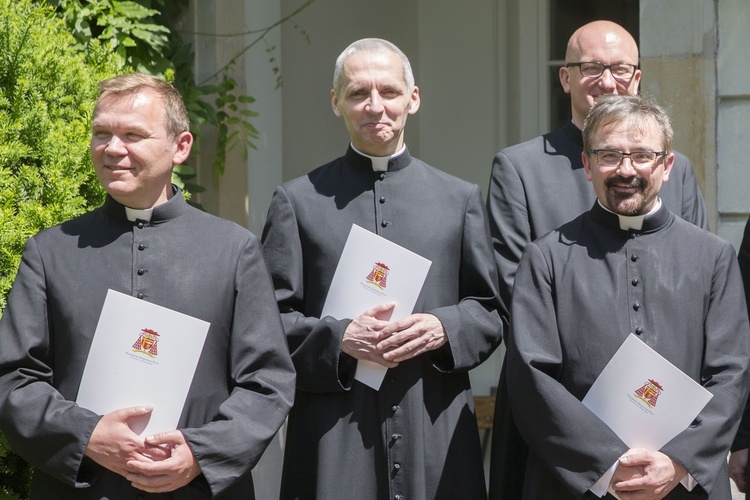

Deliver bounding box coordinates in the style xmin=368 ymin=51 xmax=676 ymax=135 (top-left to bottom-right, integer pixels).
xmin=91 ymin=90 xmax=193 ymax=209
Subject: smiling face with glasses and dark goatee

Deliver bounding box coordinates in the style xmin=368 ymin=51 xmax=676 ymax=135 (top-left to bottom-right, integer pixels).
xmin=582 ymin=118 xmax=674 ymax=216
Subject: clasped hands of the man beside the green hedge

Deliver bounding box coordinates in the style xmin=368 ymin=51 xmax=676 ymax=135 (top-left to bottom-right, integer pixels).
xmin=85 ymin=406 xmax=201 ymax=493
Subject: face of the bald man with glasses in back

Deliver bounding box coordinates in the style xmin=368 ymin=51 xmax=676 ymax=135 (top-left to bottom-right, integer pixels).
xmin=560 ymin=21 xmax=641 ymax=129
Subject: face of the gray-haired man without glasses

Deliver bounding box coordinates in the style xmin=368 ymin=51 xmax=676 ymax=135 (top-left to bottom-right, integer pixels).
xmin=331 ymin=50 xmax=419 ymax=156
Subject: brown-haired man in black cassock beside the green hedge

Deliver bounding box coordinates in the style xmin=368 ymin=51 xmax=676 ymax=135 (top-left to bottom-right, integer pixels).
xmin=0 ymin=73 xmax=294 ymax=500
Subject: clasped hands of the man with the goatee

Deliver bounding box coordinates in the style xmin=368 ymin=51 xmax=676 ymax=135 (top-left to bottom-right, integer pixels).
xmin=610 ymin=448 xmax=687 ymax=500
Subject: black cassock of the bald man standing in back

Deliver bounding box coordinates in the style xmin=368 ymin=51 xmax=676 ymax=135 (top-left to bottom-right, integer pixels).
xmin=487 ymin=121 xmax=708 ymax=500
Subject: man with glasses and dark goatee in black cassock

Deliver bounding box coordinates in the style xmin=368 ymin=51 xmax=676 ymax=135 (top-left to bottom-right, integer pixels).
xmin=507 ymin=95 xmax=750 ymax=500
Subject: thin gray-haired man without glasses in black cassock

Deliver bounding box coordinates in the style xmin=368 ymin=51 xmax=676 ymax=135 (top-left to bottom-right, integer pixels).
xmin=263 ymin=39 xmax=502 ymax=499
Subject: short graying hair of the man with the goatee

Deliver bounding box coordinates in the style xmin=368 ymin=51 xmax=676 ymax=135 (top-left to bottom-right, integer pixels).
xmin=583 ymin=94 xmax=674 ymax=152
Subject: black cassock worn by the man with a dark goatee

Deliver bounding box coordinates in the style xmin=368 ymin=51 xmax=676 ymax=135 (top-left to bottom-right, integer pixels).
xmin=507 ymin=203 xmax=750 ymax=499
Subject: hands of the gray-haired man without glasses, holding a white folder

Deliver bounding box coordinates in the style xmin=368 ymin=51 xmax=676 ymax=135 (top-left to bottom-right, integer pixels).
xmin=341 ymin=302 xmax=448 ymax=368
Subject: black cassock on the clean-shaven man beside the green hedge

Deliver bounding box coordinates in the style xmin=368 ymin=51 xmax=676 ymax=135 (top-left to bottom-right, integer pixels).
xmin=0 ymin=192 xmax=294 ymax=500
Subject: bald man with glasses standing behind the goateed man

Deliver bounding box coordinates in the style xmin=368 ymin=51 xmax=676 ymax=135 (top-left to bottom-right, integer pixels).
xmin=487 ymin=21 xmax=708 ymax=500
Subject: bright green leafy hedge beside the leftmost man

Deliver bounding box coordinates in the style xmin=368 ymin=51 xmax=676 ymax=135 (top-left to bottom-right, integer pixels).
xmin=0 ymin=0 xmax=125 ymax=498
